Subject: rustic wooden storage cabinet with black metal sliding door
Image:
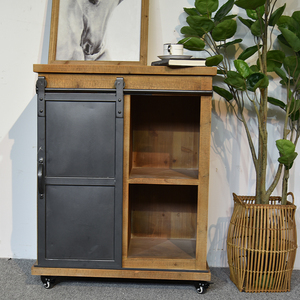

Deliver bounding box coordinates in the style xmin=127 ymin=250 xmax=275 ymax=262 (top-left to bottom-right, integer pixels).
xmin=32 ymin=64 xmax=216 ymax=287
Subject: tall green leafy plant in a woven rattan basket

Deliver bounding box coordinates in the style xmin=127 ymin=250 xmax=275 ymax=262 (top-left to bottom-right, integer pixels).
xmin=179 ymin=0 xmax=300 ymax=292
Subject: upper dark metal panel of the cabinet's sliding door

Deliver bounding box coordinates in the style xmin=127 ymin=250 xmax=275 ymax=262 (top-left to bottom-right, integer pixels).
xmin=46 ymin=101 xmax=116 ymax=178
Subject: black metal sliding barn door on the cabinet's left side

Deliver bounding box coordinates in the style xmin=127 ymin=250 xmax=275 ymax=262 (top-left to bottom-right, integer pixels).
xmin=37 ymin=78 xmax=123 ymax=268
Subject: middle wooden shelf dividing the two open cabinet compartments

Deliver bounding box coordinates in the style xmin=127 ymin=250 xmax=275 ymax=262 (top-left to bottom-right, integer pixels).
xmin=129 ymin=167 xmax=198 ymax=185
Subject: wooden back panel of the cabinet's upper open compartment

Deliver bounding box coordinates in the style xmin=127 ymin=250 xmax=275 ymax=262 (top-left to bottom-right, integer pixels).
xmin=131 ymin=96 xmax=200 ymax=169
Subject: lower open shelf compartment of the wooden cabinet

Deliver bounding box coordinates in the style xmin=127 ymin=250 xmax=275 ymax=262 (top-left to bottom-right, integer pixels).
xmin=128 ymin=184 xmax=197 ymax=259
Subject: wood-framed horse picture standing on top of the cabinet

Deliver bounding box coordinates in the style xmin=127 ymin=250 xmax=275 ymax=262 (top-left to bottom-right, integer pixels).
xmin=48 ymin=0 xmax=149 ymax=65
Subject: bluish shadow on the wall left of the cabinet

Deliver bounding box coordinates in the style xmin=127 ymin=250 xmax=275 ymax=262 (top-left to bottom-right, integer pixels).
xmin=9 ymin=97 xmax=37 ymax=258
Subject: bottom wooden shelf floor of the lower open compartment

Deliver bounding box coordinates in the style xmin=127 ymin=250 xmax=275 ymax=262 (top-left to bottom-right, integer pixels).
xmin=128 ymin=237 xmax=196 ymax=259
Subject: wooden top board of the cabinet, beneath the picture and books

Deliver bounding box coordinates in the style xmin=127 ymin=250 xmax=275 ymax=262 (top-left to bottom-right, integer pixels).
xmin=33 ymin=63 xmax=217 ymax=76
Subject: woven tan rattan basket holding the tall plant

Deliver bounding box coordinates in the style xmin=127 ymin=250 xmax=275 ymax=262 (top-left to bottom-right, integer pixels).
xmin=227 ymin=193 xmax=297 ymax=292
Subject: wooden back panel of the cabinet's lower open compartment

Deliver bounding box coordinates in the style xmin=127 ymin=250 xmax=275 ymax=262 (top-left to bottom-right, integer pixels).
xmin=129 ymin=184 xmax=198 ymax=239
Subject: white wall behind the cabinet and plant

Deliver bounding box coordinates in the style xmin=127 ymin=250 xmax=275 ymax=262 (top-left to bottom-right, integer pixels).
xmin=0 ymin=0 xmax=300 ymax=269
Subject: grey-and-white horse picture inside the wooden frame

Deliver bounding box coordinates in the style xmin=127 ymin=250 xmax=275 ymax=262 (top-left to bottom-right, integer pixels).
xmin=56 ymin=0 xmax=142 ymax=61
